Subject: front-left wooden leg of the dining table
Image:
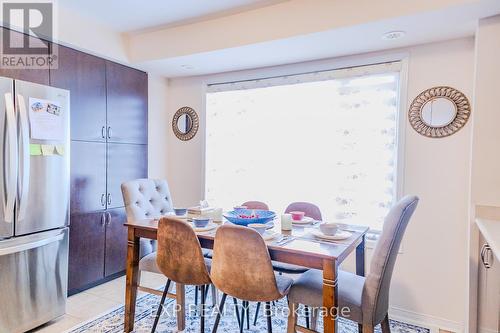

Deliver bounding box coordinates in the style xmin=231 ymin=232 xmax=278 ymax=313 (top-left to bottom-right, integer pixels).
xmin=124 ymin=228 xmax=139 ymax=333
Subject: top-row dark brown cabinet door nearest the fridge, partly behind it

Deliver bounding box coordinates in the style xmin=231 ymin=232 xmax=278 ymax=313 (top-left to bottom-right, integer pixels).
xmin=50 ymin=46 xmax=106 ymax=142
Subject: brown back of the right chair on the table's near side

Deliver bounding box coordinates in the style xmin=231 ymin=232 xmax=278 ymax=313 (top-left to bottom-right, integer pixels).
xmin=210 ymin=224 xmax=282 ymax=302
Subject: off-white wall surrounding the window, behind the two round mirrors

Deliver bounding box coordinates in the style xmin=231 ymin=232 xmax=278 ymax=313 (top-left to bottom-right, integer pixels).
xmin=167 ymin=39 xmax=474 ymax=331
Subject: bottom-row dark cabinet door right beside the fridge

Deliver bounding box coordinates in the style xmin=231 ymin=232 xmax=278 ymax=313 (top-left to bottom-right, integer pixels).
xmin=68 ymin=212 xmax=106 ymax=292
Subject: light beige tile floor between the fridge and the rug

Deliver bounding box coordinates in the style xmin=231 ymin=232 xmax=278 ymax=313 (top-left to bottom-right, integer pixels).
xmin=33 ymin=272 xmax=166 ymax=333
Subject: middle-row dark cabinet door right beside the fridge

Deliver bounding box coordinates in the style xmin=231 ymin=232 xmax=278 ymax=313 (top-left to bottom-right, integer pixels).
xmin=70 ymin=141 xmax=106 ymax=213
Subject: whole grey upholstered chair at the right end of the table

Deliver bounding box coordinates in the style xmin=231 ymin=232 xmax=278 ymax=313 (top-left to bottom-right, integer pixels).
xmin=287 ymin=196 xmax=418 ymax=333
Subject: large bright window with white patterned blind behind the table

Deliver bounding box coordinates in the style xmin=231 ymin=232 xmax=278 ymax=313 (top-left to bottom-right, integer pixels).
xmin=205 ymin=63 xmax=400 ymax=230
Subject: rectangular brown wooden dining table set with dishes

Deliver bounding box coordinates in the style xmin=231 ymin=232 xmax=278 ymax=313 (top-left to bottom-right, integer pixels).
xmin=124 ymin=219 xmax=368 ymax=333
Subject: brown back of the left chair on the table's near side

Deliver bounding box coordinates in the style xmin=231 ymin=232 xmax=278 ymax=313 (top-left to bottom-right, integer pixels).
xmin=156 ymin=217 xmax=211 ymax=285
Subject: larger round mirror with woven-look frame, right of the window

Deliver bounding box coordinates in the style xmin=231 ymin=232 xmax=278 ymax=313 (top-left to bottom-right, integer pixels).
xmin=408 ymin=86 xmax=471 ymax=138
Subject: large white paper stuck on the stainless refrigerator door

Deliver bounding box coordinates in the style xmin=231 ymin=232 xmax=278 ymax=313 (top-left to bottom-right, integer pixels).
xmin=28 ymin=97 xmax=64 ymax=141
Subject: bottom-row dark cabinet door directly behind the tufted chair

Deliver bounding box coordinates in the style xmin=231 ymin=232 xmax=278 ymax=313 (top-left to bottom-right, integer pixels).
xmin=104 ymin=208 xmax=127 ymax=276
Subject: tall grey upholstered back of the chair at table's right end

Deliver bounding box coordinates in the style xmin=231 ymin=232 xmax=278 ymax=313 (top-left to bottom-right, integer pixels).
xmin=362 ymin=196 xmax=419 ymax=325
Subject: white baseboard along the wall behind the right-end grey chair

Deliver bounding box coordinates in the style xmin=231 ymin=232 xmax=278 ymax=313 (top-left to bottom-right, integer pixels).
xmin=389 ymin=306 xmax=464 ymax=333
